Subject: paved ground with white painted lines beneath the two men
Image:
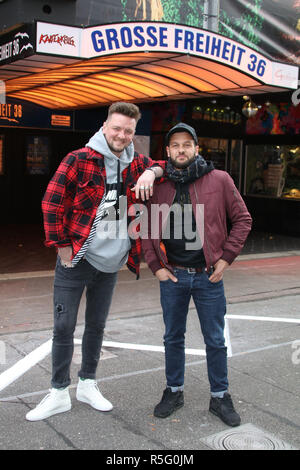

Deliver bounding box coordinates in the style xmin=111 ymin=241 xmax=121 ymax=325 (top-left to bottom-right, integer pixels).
xmin=0 ymin=224 xmax=300 ymax=452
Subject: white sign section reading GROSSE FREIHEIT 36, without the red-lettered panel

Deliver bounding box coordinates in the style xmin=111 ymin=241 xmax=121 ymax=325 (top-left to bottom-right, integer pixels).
xmin=82 ymin=23 xmax=298 ymax=88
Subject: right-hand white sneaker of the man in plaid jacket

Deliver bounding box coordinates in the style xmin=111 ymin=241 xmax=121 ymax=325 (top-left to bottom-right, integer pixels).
xmin=76 ymin=379 xmax=113 ymax=411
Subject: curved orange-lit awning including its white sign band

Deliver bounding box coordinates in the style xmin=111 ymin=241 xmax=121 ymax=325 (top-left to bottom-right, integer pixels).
xmin=0 ymin=23 xmax=298 ymax=109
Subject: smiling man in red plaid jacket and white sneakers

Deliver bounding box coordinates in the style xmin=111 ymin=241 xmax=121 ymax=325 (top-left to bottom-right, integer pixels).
xmin=26 ymin=103 xmax=163 ymax=421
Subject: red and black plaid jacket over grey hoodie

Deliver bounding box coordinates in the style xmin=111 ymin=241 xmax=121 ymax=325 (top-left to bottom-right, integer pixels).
xmin=42 ymin=147 xmax=165 ymax=276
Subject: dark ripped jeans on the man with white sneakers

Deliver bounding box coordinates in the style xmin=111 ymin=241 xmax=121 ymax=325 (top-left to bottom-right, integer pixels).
xmin=51 ymin=257 xmax=117 ymax=388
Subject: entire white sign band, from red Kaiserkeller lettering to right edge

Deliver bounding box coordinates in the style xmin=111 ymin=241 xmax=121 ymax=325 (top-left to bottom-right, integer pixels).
xmin=36 ymin=22 xmax=298 ymax=89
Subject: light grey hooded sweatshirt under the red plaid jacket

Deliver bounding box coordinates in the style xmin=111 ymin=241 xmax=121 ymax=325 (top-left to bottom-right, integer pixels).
xmin=85 ymin=128 xmax=134 ymax=273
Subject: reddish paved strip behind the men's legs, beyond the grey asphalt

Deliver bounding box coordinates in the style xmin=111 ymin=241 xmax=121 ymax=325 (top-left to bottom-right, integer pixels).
xmin=0 ymin=250 xmax=300 ymax=334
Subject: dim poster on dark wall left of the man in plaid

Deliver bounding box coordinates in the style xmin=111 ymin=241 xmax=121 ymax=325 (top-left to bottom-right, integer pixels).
xmin=26 ymin=136 xmax=50 ymax=175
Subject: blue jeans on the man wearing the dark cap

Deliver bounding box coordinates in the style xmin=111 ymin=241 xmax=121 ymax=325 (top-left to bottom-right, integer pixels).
xmin=160 ymin=268 xmax=228 ymax=393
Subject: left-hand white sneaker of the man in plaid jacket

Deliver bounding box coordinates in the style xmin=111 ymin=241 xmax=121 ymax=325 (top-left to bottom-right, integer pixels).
xmin=26 ymin=387 xmax=71 ymax=421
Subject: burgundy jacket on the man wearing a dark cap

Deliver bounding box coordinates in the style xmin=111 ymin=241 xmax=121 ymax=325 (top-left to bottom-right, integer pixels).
xmin=141 ymin=170 xmax=252 ymax=274
